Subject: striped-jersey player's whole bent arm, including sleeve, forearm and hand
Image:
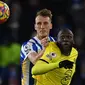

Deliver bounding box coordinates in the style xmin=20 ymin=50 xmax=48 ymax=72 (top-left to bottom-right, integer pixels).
xmin=20 ymin=37 xmax=48 ymax=64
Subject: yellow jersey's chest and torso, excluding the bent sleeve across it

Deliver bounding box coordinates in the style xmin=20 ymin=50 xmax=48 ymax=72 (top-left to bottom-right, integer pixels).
xmin=33 ymin=42 xmax=78 ymax=85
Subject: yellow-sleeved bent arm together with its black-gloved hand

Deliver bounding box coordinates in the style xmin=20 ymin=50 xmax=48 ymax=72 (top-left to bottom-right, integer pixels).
xmin=32 ymin=59 xmax=74 ymax=75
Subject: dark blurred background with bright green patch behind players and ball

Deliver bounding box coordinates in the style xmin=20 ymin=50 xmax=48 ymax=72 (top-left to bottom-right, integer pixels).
xmin=0 ymin=0 xmax=85 ymax=85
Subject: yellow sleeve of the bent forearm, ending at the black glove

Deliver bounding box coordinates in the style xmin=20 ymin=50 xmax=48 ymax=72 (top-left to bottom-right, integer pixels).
xmin=31 ymin=60 xmax=59 ymax=75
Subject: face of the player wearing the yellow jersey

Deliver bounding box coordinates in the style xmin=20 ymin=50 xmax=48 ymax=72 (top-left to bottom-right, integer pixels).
xmin=58 ymin=30 xmax=74 ymax=49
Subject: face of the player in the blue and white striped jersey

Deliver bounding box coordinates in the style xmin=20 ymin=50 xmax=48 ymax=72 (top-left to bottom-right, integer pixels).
xmin=35 ymin=15 xmax=52 ymax=39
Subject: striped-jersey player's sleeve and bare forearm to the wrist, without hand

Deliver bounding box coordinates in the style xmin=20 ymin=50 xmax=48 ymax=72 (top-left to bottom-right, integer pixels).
xmin=20 ymin=42 xmax=45 ymax=64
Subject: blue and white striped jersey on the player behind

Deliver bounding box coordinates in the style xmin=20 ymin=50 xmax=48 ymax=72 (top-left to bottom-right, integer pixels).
xmin=20 ymin=36 xmax=55 ymax=85
